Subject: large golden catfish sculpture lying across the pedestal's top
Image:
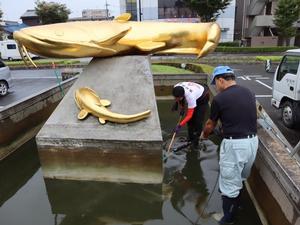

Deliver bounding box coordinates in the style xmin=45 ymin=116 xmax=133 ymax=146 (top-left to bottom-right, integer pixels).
xmin=13 ymin=13 xmax=221 ymax=67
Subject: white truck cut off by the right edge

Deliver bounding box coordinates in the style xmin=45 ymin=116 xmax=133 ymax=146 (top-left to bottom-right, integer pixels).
xmin=271 ymin=49 xmax=300 ymax=128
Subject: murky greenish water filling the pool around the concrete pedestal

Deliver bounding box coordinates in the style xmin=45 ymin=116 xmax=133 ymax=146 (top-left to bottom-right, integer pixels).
xmin=0 ymin=101 xmax=261 ymax=225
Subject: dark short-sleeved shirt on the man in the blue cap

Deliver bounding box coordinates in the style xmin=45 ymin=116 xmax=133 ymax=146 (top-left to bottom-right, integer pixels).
xmin=210 ymin=85 xmax=257 ymax=137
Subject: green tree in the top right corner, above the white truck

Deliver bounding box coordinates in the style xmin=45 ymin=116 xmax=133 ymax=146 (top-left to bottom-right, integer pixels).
xmin=274 ymin=0 xmax=300 ymax=46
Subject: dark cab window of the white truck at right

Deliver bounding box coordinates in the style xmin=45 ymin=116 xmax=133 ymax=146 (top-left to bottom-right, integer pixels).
xmin=276 ymin=55 xmax=300 ymax=81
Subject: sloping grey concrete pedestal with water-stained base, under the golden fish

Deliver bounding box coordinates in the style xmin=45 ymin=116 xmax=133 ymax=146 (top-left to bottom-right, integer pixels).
xmin=36 ymin=56 xmax=162 ymax=183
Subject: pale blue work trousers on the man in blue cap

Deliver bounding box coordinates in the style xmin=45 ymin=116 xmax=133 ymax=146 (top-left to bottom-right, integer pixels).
xmin=219 ymin=136 xmax=258 ymax=198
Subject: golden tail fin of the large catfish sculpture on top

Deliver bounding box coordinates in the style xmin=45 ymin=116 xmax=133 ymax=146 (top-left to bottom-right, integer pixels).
xmin=198 ymin=23 xmax=221 ymax=58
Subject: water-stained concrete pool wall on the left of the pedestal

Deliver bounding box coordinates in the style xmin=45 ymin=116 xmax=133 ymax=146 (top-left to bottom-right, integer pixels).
xmin=0 ymin=77 xmax=77 ymax=160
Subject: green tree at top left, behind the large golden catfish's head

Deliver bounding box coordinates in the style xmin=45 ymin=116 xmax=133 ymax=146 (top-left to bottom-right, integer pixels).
xmin=35 ymin=0 xmax=71 ymax=24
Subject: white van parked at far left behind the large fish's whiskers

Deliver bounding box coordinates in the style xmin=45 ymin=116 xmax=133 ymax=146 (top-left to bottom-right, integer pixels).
xmin=0 ymin=40 xmax=36 ymax=60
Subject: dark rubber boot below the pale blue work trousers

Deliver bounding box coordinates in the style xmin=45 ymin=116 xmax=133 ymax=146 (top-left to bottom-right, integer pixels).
xmin=219 ymin=195 xmax=239 ymax=225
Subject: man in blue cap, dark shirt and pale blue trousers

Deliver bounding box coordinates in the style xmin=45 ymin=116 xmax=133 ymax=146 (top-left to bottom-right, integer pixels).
xmin=200 ymin=66 xmax=258 ymax=224
